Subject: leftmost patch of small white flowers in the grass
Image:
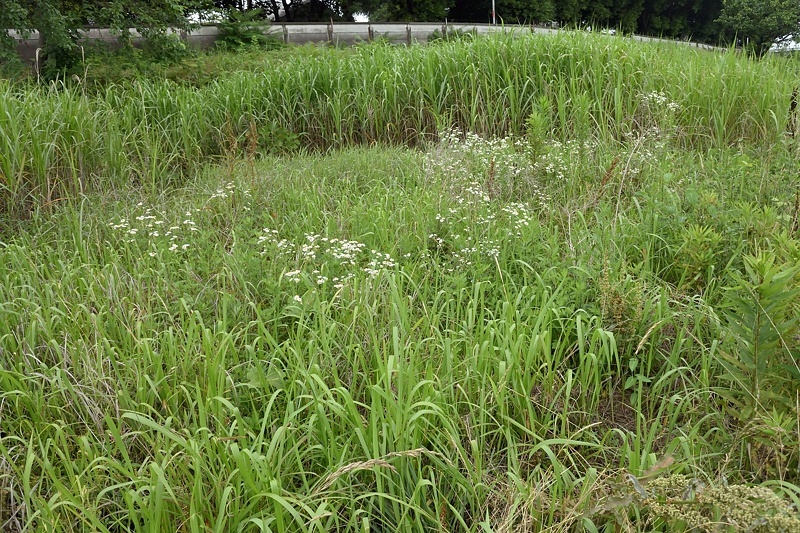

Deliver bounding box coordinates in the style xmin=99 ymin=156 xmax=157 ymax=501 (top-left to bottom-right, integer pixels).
xmin=108 ymin=202 xmax=198 ymax=257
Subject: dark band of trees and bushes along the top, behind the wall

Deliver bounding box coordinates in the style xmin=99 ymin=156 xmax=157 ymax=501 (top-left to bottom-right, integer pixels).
xmin=0 ymin=0 xmax=800 ymax=79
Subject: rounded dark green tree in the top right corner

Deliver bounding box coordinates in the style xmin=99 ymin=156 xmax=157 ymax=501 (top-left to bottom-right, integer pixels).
xmin=717 ymin=0 xmax=800 ymax=57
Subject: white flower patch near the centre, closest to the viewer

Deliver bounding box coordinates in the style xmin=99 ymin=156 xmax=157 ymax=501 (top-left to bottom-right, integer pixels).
xmin=258 ymin=228 xmax=397 ymax=289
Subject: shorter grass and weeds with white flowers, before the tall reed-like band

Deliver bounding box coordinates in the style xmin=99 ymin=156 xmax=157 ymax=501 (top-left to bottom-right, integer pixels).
xmin=0 ymin=34 xmax=800 ymax=531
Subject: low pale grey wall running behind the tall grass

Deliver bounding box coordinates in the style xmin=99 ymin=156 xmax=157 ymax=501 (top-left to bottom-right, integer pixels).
xmin=8 ymin=22 xmax=716 ymax=60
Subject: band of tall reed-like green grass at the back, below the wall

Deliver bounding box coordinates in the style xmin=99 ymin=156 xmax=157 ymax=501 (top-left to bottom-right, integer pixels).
xmin=0 ymin=32 xmax=795 ymax=220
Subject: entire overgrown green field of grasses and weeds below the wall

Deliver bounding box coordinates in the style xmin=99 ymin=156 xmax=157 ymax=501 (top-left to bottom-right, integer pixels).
xmin=0 ymin=33 xmax=800 ymax=532
